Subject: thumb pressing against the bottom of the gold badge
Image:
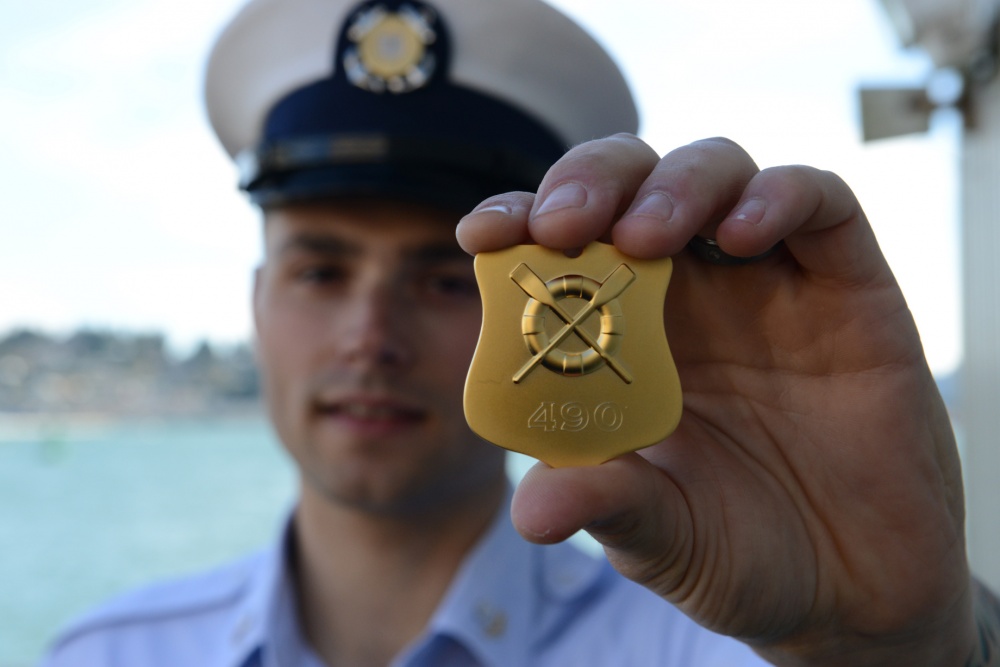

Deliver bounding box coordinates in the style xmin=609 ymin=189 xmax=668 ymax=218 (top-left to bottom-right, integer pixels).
xmin=511 ymin=454 xmax=692 ymax=596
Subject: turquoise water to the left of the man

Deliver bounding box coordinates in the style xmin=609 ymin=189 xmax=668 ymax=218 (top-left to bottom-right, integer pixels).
xmin=0 ymin=415 xmax=295 ymax=667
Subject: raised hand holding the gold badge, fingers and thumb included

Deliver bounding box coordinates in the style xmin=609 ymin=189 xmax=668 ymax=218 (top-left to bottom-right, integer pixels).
xmin=458 ymin=135 xmax=974 ymax=667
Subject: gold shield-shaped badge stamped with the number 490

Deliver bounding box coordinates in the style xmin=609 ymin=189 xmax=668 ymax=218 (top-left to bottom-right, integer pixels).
xmin=465 ymin=243 xmax=682 ymax=466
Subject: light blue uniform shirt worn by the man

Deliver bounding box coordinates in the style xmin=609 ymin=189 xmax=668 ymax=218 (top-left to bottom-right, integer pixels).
xmin=43 ymin=504 xmax=767 ymax=667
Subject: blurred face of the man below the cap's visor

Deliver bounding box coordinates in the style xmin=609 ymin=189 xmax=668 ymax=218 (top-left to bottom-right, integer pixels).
xmin=254 ymin=201 xmax=503 ymax=514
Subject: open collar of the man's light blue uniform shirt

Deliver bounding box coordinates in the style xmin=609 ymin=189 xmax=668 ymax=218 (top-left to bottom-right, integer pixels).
xmin=223 ymin=488 xmax=608 ymax=667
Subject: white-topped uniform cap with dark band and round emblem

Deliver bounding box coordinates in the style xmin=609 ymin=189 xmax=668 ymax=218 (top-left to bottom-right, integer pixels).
xmin=205 ymin=0 xmax=638 ymax=207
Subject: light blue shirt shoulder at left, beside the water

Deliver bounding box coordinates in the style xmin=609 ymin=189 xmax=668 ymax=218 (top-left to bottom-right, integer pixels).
xmin=43 ymin=551 xmax=270 ymax=667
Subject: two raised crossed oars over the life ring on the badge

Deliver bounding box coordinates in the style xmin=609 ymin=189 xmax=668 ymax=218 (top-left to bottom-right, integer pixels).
xmin=510 ymin=263 xmax=635 ymax=384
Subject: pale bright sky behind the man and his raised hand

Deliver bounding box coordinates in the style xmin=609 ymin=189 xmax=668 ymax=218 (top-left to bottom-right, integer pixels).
xmin=0 ymin=0 xmax=961 ymax=372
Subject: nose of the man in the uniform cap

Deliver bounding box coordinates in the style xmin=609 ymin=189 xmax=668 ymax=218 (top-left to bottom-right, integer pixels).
xmin=334 ymin=285 xmax=413 ymax=367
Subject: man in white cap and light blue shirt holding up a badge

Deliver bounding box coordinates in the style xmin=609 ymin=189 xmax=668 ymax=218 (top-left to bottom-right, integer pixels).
xmin=43 ymin=0 xmax=1000 ymax=667
